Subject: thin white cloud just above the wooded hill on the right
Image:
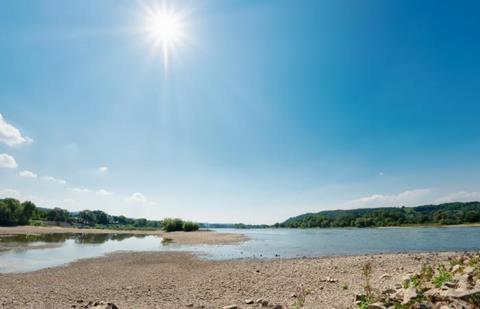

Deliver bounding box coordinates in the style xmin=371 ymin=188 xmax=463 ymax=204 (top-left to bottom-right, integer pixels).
xmin=343 ymin=189 xmax=432 ymax=208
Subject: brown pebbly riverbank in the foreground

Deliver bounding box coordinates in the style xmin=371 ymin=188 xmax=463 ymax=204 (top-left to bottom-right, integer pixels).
xmin=0 ymin=252 xmax=466 ymax=309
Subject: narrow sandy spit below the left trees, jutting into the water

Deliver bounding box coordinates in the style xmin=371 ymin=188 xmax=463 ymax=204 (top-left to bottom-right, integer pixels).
xmin=0 ymin=225 xmax=248 ymax=245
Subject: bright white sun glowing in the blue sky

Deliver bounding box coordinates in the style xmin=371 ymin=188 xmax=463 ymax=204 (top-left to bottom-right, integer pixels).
xmin=143 ymin=2 xmax=186 ymax=68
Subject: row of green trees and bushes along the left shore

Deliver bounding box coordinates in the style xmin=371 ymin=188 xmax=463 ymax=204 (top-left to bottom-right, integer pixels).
xmin=0 ymin=198 xmax=199 ymax=231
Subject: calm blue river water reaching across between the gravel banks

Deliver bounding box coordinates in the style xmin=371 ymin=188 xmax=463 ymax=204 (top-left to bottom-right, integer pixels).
xmin=0 ymin=227 xmax=480 ymax=273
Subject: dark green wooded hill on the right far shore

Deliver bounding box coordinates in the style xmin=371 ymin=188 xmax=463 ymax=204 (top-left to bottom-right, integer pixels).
xmin=274 ymin=202 xmax=480 ymax=228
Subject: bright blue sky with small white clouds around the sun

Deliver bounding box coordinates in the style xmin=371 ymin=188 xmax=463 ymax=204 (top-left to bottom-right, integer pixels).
xmin=0 ymin=0 xmax=480 ymax=223
